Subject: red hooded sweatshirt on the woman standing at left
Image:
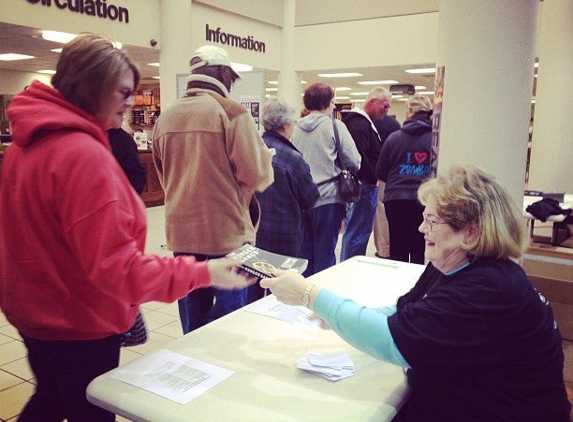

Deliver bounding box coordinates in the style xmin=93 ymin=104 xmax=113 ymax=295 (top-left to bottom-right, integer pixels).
xmin=0 ymin=81 xmax=210 ymax=340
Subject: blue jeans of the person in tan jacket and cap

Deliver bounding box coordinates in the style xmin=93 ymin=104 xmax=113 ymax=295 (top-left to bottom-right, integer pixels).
xmin=173 ymin=252 xmax=247 ymax=334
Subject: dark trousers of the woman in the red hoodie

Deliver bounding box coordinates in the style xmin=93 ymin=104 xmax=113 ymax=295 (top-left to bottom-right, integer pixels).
xmin=18 ymin=335 xmax=120 ymax=422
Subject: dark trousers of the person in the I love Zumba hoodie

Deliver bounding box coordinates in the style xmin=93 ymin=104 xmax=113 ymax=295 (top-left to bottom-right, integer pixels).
xmin=384 ymin=200 xmax=426 ymax=264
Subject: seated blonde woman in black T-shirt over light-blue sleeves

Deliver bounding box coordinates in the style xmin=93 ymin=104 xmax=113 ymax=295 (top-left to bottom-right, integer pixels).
xmin=261 ymin=164 xmax=571 ymax=422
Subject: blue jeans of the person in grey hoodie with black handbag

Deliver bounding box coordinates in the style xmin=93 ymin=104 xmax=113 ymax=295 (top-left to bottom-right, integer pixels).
xmin=300 ymin=203 xmax=346 ymax=277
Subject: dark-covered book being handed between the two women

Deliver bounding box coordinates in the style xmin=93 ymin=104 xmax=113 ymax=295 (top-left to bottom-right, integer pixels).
xmin=227 ymin=244 xmax=308 ymax=278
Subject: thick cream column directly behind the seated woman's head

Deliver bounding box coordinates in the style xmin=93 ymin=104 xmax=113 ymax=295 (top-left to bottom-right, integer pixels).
xmin=436 ymin=0 xmax=539 ymax=205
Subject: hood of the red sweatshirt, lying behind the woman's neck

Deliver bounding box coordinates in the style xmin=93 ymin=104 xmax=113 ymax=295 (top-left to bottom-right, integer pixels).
xmin=7 ymin=81 xmax=110 ymax=149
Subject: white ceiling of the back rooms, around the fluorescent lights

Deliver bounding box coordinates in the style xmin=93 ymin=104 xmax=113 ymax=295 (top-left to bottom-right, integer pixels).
xmin=0 ymin=22 xmax=434 ymax=102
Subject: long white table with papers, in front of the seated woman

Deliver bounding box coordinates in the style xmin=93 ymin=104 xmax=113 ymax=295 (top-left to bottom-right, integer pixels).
xmin=87 ymin=257 xmax=424 ymax=422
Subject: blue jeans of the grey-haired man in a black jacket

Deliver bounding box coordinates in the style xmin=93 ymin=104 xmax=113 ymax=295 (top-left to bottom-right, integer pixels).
xmin=340 ymin=183 xmax=378 ymax=261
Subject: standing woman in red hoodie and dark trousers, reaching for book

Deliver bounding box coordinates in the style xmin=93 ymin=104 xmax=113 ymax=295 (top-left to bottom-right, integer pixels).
xmin=0 ymin=34 xmax=252 ymax=422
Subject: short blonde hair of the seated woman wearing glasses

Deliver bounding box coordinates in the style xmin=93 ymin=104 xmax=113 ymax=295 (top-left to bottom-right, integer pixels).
xmin=418 ymin=164 xmax=528 ymax=259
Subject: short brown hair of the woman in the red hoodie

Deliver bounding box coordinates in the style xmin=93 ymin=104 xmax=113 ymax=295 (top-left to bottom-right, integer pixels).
xmin=52 ymin=32 xmax=141 ymax=115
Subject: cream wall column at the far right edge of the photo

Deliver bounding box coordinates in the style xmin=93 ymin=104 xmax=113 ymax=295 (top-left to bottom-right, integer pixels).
xmin=528 ymin=0 xmax=573 ymax=193
